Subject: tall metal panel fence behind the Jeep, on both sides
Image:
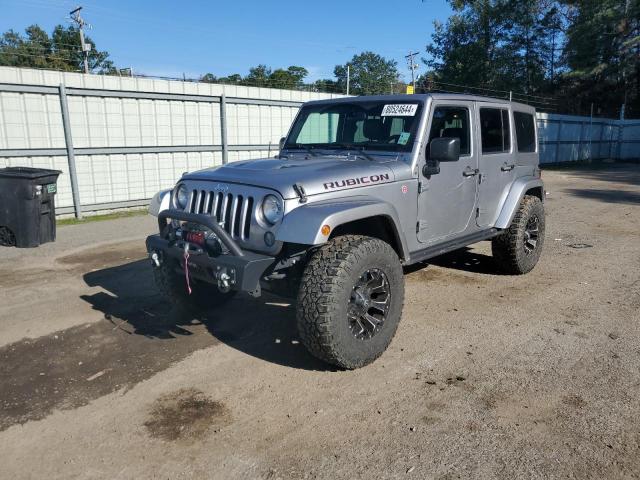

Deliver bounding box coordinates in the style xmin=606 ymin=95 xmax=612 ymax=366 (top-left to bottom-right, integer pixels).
xmin=0 ymin=67 xmax=640 ymax=216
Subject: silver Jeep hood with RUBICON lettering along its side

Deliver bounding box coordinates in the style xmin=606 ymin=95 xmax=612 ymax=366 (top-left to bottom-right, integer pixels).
xmin=183 ymin=156 xmax=410 ymax=199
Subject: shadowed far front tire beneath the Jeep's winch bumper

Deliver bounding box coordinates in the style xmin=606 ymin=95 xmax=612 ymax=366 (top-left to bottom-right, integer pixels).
xmin=153 ymin=260 xmax=237 ymax=312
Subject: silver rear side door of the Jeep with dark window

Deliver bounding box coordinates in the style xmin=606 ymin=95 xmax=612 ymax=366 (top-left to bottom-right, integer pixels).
xmin=476 ymin=103 xmax=515 ymax=227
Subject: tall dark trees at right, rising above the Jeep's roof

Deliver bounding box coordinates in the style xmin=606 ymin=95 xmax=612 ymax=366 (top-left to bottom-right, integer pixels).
xmin=421 ymin=0 xmax=640 ymax=115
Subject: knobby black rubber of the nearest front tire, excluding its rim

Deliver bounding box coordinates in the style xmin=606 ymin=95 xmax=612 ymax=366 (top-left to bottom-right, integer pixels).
xmin=296 ymin=235 xmax=404 ymax=369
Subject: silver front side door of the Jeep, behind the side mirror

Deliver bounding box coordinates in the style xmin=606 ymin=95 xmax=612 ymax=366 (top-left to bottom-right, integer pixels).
xmin=417 ymin=101 xmax=478 ymax=244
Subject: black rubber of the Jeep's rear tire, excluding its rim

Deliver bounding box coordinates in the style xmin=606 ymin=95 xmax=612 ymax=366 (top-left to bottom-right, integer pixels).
xmin=491 ymin=195 xmax=545 ymax=275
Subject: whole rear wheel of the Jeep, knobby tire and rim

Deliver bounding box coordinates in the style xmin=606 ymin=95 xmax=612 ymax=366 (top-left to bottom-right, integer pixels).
xmin=491 ymin=195 xmax=545 ymax=275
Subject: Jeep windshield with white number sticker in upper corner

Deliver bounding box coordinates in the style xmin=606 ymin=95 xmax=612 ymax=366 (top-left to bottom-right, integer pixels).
xmin=285 ymin=100 xmax=422 ymax=152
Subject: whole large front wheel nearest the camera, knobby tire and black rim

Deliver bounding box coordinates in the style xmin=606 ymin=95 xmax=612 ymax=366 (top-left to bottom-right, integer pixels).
xmin=297 ymin=235 xmax=404 ymax=369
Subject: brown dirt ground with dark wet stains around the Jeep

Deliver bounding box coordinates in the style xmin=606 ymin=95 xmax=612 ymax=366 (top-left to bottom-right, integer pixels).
xmin=0 ymin=165 xmax=640 ymax=480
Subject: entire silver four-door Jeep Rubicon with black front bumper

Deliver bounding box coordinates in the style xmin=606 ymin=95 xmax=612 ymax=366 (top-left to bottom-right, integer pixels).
xmin=147 ymin=94 xmax=545 ymax=368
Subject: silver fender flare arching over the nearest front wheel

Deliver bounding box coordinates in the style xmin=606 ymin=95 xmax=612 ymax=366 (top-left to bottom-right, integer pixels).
xmin=276 ymin=195 xmax=408 ymax=258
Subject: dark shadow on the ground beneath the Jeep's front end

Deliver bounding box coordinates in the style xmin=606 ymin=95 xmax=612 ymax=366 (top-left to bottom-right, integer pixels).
xmin=81 ymin=260 xmax=334 ymax=371
